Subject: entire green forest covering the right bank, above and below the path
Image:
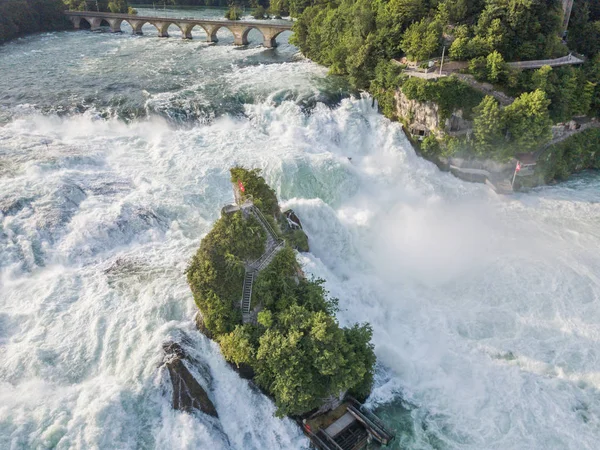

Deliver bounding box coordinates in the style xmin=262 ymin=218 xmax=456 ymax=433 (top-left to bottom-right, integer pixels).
xmin=289 ymin=0 xmax=600 ymax=160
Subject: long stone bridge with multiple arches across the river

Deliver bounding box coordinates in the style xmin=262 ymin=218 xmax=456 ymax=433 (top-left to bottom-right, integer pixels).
xmin=65 ymin=11 xmax=293 ymax=48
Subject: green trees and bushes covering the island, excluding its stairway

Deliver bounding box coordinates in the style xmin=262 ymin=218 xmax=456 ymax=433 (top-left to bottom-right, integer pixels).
xmin=187 ymin=167 xmax=375 ymax=415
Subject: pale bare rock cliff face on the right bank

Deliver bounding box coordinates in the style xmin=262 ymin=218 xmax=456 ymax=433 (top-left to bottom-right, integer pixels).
xmin=394 ymin=89 xmax=473 ymax=137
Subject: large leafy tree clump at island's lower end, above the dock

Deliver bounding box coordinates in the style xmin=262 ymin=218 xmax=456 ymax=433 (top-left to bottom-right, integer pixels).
xmin=256 ymin=305 xmax=375 ymax=416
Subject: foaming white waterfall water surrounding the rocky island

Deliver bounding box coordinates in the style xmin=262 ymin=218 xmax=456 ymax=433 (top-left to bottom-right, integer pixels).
xmin=0 ymin=12 xmax=600 ymax=450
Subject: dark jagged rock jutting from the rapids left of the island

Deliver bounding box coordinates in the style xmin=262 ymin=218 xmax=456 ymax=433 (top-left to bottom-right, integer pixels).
xmin=163 ymin=342 xmax=219 ymax=417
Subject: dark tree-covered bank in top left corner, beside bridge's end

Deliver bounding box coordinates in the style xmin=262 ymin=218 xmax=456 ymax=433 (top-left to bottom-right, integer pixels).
xmin=0 ymin=0 xmax=69 ymax=43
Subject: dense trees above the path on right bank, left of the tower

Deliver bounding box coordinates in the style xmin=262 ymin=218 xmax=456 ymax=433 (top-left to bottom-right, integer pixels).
xmin=290 ymin=0 xmax=564 ymax=88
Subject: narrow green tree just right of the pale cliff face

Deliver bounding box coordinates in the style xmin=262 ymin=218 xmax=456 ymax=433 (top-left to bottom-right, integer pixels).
xmin=473 ymin=95 xmax=504 ymax=156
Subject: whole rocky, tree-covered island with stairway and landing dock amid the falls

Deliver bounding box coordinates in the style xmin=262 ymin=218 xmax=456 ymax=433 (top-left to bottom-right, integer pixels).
xmin=187 ymin=167 xmax=393 ymax=449
